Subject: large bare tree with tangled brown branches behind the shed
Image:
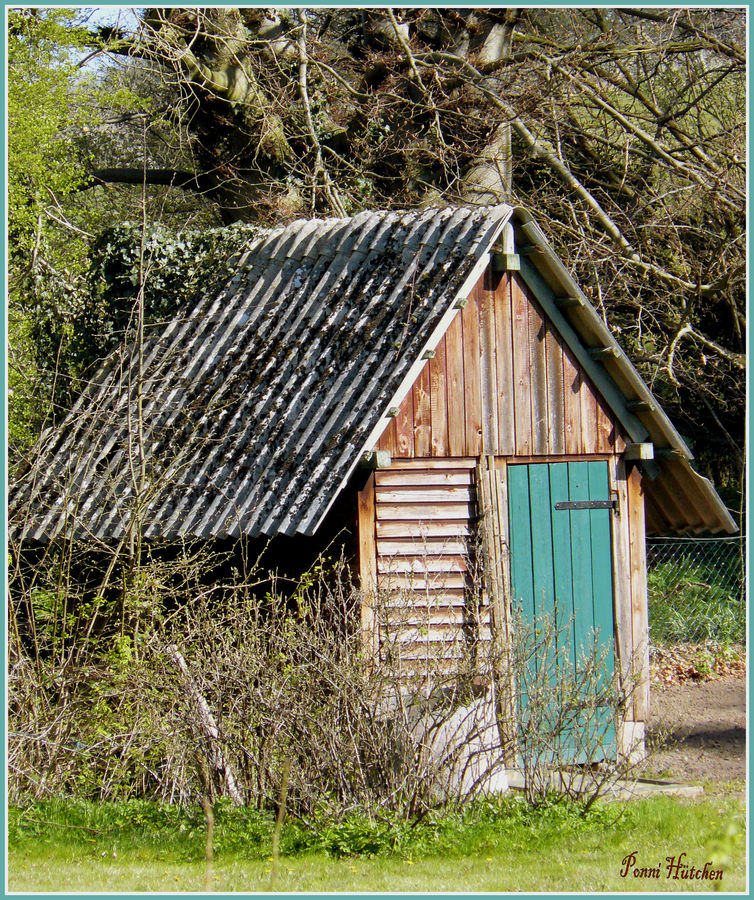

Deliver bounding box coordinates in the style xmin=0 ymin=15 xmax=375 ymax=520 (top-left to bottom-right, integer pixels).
xmin=73 ymin=8 xmax=746 ymax=488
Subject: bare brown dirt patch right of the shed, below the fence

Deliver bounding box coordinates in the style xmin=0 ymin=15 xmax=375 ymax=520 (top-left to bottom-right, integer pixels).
xmin=645 ymin=660 xmax=746 ymax=784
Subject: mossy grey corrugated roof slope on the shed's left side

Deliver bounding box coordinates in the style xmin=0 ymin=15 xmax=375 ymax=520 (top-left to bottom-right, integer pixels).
xmin=11 ymin=206 xmax=511 ymax=540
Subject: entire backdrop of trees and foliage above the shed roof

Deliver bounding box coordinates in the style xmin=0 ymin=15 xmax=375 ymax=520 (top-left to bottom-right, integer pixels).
xmin=8 ymin=7 xmax=747 ymax=512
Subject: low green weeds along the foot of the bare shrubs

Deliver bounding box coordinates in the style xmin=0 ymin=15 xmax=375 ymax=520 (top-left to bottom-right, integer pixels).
xmin=8 ymin=794 xmax=617 ymax=860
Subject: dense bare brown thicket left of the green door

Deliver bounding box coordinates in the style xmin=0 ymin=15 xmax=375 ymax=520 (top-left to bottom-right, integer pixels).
xmin=9 ymin=548 xmax=502 ymax=816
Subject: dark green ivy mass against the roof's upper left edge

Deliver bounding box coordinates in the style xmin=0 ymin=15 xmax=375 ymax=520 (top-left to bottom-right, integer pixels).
xmin=11 ymin=222 xmax=257 ymax=446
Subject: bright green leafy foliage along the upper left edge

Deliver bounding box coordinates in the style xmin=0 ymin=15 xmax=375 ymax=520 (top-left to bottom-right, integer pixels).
xmin=7 ymin=7 xmax=138 ymax=453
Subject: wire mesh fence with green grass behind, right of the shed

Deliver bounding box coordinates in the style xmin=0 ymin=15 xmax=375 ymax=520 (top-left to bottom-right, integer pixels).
xmin=647 ymin=536 xmax=746 ymax=646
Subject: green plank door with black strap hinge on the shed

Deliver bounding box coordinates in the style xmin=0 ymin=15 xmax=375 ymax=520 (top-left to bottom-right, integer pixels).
xmin=508 ymin=461 xmax=615 ymax=762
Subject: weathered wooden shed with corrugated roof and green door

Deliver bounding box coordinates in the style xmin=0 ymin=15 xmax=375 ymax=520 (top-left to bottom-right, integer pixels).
xmin=11 ymin=206 xmax=736 ymax=760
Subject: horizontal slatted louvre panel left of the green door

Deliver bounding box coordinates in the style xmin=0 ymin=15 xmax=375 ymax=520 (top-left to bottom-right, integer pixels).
xmin=375 ymin=458 xmax=490 ymax=674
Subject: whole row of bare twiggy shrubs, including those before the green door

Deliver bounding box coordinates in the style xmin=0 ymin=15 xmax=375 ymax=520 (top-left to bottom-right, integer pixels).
xmin=8 ymin=540 xmax=636 ymax=821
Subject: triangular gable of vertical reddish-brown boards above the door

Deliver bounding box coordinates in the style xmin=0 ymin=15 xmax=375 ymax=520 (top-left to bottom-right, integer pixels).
xmin=378 ymin=269 xmax=625 ymax=459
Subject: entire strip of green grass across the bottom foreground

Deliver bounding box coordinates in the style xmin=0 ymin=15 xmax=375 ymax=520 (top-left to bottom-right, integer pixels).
xmin=8 ymin=796 xmax=745 ymax=893
